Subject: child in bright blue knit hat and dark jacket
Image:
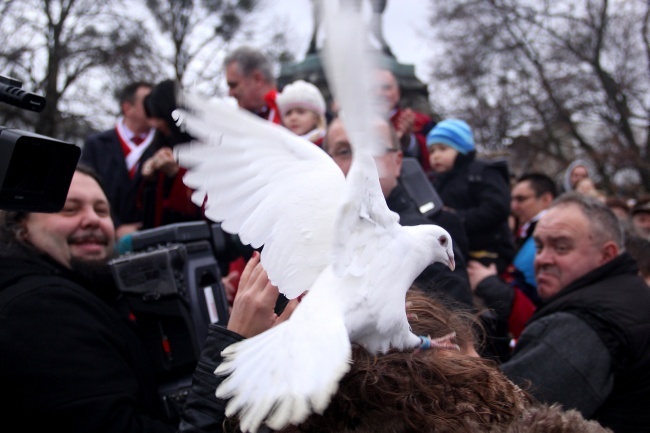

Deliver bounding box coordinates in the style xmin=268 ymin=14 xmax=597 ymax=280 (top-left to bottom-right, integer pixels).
xmin=427 ymin=119 xmax=514 ymax=273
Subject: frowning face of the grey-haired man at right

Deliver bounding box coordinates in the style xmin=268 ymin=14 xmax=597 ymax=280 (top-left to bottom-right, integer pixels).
xmin=533 ymin=204 xmax=614 ymax=299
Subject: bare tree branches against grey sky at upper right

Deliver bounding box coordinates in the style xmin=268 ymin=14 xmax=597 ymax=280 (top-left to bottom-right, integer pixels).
xmin=431 ymin=0 xmax=650 ymax=192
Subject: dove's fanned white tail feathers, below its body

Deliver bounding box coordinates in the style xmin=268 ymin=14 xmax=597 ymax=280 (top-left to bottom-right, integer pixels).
xmin=215 ymin=294 xmax=351 ymax=432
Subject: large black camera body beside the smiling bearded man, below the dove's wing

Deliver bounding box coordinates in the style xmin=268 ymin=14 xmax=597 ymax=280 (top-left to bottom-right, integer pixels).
xmin=110 ymin=221 xmax=229 ymax=419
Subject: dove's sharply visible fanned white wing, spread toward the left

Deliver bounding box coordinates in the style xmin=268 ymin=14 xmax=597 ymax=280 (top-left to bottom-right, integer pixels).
xmin=175 ymin=95 xmax=345 ymax=298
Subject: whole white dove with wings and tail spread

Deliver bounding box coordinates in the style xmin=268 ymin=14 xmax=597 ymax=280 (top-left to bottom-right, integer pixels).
xmin=175 ymin=1 xmax=454 ymax=432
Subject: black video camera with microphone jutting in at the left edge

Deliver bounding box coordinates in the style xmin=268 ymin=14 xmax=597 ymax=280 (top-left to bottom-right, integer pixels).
xmin=0 ymin=75 xmax=81 ymax=212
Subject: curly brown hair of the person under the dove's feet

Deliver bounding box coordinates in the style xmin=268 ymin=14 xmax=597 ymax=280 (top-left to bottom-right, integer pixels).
xmin=268 ymin=290 xmax=531 ymax=433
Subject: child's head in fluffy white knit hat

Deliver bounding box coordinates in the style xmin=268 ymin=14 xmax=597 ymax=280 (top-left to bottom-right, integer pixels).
xmin=275 ymin=80 xmax=326 ymax=146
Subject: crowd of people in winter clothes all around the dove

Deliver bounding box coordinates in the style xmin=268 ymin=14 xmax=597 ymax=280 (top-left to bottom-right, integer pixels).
xmin=0 ymin=41 xmax=650 ymax=433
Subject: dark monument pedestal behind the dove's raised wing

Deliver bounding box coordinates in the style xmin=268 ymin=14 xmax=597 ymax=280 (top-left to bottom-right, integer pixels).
xmin=278 ymin=53 xmax=435 ymax=117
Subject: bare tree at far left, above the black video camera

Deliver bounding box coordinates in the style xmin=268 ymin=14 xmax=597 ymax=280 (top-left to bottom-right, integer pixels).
xmin=0 ymin=0 xmax=159 ymax=141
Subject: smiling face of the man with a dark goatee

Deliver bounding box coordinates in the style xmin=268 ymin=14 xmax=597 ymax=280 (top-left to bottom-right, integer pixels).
xmin=21 ymin=171 xmax=115 ymax=268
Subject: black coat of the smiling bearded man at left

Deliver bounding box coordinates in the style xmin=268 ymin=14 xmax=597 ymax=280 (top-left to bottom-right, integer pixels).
xmin=0 ymin=246 xmax=176 ymax=433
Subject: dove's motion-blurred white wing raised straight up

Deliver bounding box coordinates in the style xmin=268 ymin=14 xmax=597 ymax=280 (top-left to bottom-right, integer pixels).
xmin=323 ymin=1 xmax=400 ymax=275
